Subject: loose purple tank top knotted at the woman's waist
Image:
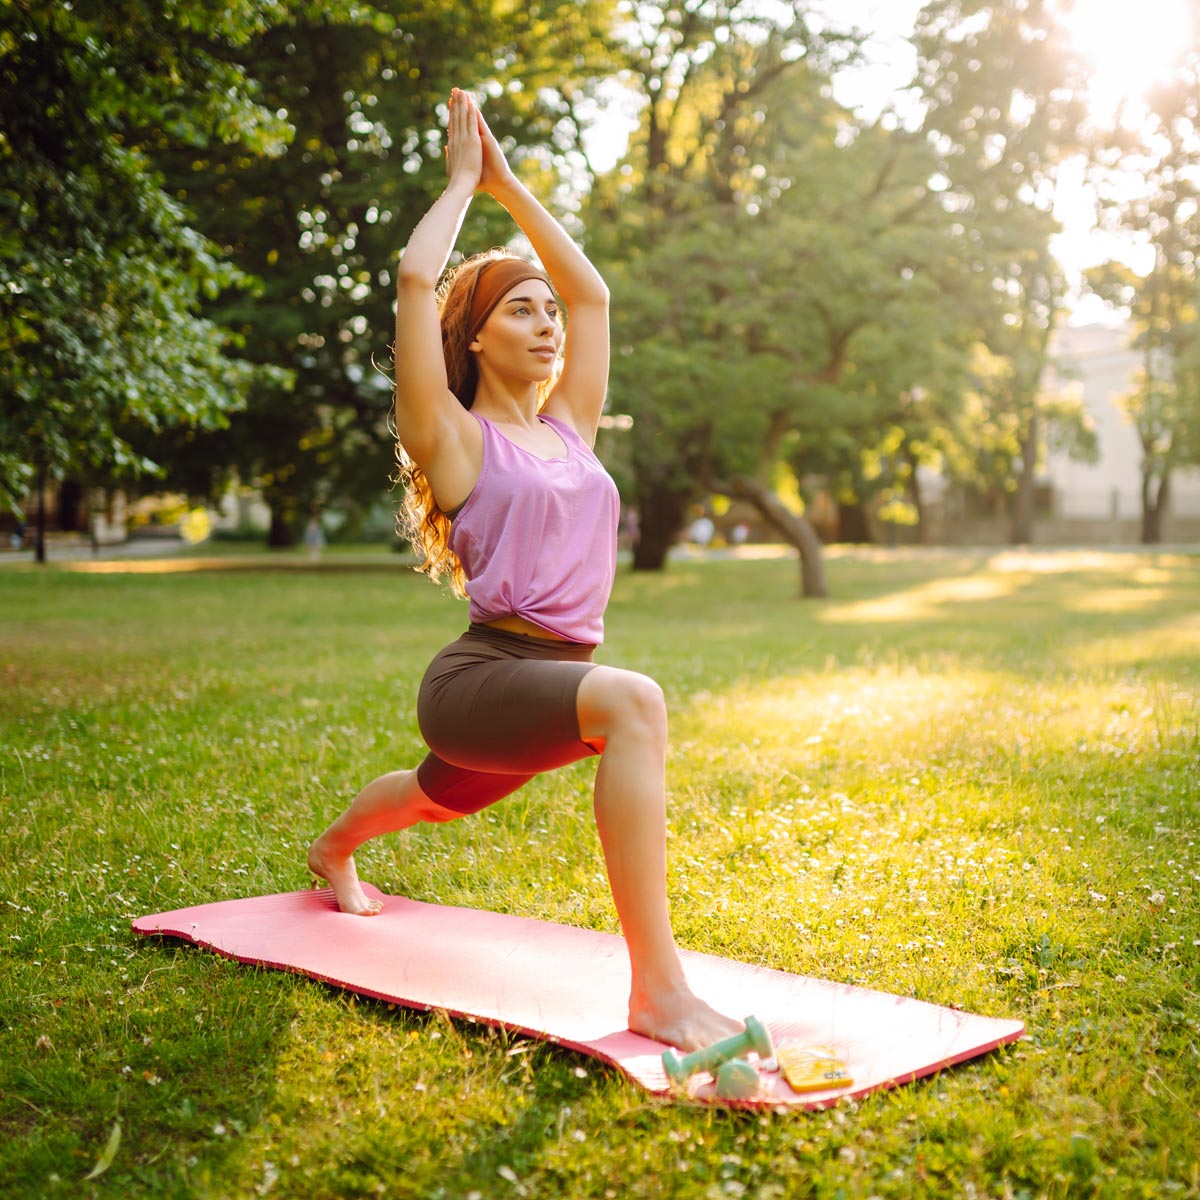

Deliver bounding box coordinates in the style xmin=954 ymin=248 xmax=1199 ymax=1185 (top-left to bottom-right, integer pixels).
xmin=450 ymin=413 xmax=620 ymax=646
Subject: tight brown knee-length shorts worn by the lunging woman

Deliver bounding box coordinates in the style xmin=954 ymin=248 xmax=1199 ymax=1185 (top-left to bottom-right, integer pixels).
xmin=416 ymin=625 xmax=596 ymax=812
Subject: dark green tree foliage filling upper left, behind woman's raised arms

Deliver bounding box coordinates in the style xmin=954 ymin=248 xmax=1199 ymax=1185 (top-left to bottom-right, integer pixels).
xmin=0 ymin=0 xmax=611 ymax=540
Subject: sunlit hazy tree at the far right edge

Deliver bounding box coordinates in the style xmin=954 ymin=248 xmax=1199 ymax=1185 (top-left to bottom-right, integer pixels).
xmin=1088 ymin=54 xmax=1200 ymax=544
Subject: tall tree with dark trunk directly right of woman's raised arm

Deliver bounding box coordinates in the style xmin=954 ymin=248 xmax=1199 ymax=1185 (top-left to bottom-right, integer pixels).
xmin=587 ymin=0 xmax=853 ymax=590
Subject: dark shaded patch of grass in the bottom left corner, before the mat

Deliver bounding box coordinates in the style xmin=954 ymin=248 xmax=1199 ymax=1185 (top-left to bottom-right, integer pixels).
xmin=0 ymin=938 xmax=292 ymax=1196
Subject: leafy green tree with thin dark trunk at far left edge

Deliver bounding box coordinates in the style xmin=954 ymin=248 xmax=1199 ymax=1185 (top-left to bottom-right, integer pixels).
xmin=0 ymin=0 xmax=288 ymax=560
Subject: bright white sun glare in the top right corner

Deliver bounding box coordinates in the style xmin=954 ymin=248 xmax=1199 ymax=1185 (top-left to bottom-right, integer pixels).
xmin=1068 ymin=0 xmax=1198 ymax=115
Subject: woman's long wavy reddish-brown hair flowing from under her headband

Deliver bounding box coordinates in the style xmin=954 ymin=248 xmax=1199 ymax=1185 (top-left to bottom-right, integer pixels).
xmin=396 ymin=250 xmax=554 ymax=598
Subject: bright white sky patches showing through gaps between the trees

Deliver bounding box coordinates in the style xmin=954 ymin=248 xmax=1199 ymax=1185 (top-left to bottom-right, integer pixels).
xmin=578 ymin=0 xmax=1200 ymax=320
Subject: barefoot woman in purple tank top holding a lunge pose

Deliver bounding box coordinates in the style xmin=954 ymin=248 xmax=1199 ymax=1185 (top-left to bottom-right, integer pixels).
xmin=308 ymin=89 xmax=740 ymax=1050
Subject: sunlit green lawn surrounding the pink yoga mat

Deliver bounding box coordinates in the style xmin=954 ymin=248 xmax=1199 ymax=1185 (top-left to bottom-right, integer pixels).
xmin=0 ymin=552 xmax=1200 ymax=1200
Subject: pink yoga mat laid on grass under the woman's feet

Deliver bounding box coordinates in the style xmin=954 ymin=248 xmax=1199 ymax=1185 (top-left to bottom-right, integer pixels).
xmin=133 ymin=887 xmax=1025 ymax=1109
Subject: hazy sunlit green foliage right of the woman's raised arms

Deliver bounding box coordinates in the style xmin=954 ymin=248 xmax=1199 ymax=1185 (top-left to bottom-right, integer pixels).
xmin=587 ymin=0 xmax=1099 ymax=559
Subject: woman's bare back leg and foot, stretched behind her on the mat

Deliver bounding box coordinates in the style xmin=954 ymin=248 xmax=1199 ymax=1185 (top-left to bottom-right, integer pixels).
xmin=308 ymin=770 xmax=466 ymax=917
